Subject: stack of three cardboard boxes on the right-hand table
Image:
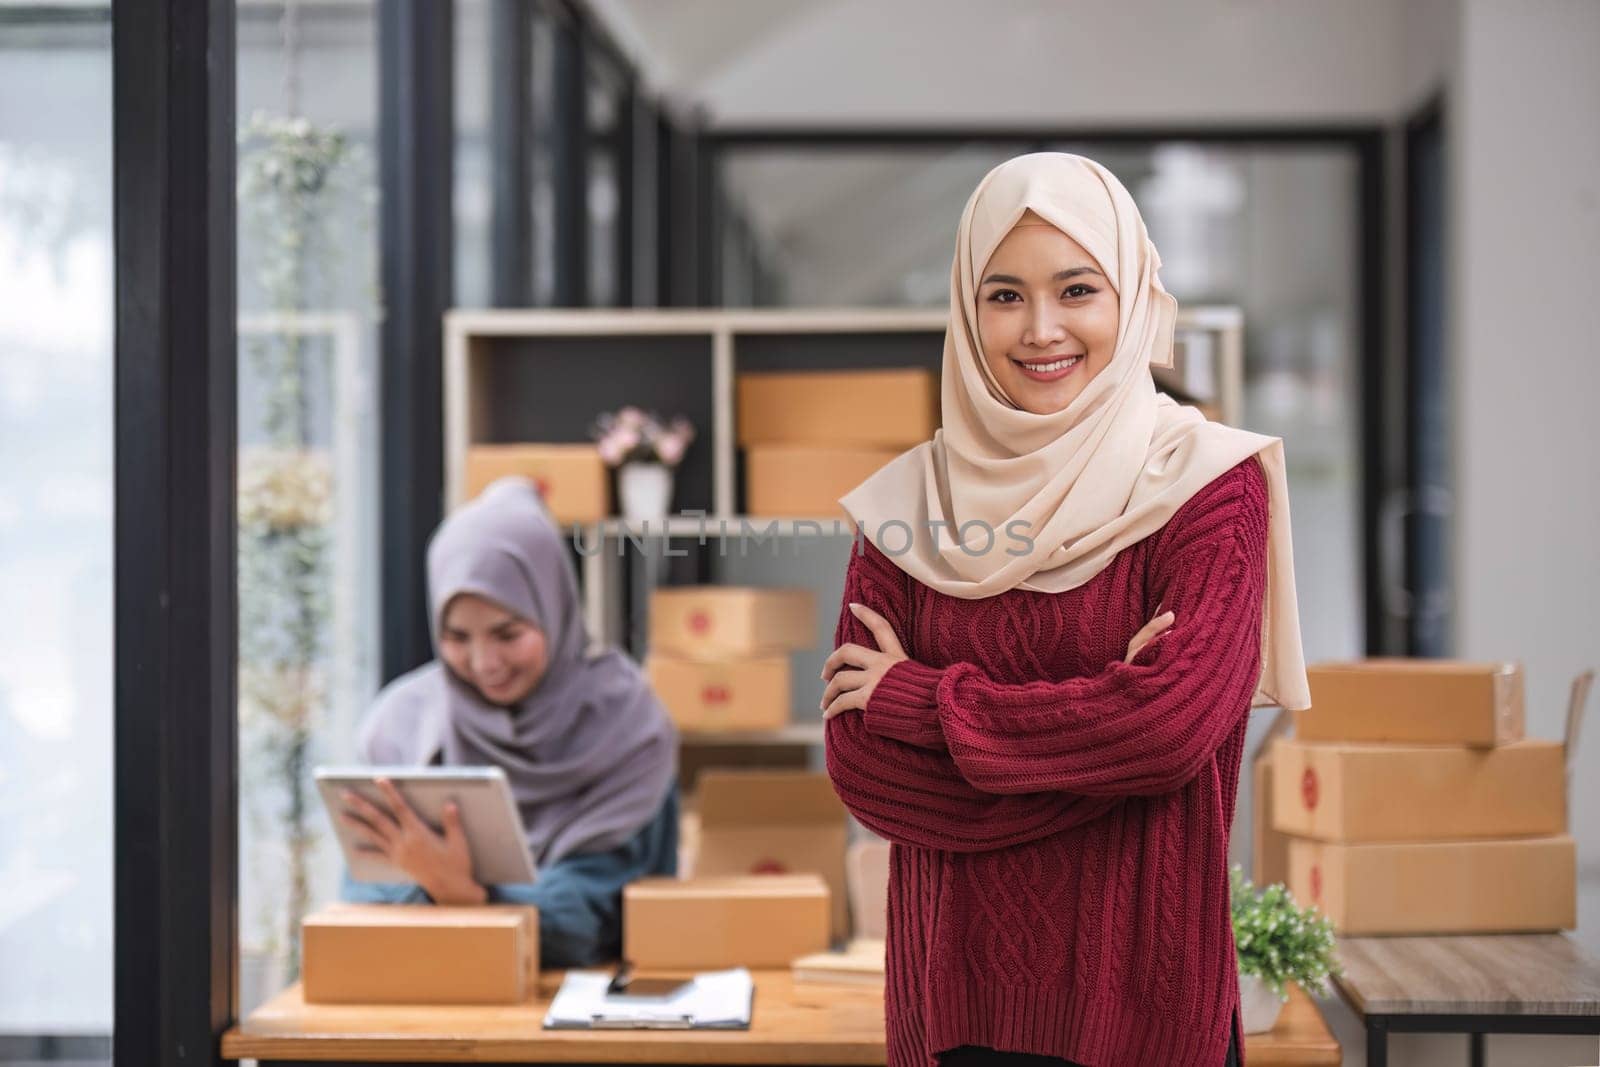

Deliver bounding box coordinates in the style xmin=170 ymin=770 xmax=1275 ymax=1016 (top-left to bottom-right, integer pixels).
xmin=1258 ymin=659 xmax=1576 ymax=934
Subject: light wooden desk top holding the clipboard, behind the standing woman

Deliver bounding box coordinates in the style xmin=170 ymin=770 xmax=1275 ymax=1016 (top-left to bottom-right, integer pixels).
xmin=222 ymin=971 xmax=1341 ymax=1067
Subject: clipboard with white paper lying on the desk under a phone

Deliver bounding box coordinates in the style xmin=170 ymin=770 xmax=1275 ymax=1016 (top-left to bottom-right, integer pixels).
xmin=544 ymin=968 xmax=755 ymax=1030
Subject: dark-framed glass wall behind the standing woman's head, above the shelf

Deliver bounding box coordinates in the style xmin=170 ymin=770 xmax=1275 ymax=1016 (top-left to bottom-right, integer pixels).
xmin=718 ymin=142 xmax=1365 ymax=659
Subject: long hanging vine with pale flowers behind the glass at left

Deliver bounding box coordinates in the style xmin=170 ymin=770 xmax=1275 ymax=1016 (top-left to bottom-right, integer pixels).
xmin=238 ymin=112 xmax=373 ymax=976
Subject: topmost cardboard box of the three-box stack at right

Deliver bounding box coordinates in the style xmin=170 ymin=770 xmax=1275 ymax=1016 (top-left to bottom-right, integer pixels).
xmin=1294 ymin=657 xmax=1525 ymax=747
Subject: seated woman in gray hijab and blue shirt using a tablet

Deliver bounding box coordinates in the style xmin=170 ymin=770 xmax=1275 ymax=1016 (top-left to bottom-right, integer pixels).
xmin=341 ymin=478 xmax=678 ymax=968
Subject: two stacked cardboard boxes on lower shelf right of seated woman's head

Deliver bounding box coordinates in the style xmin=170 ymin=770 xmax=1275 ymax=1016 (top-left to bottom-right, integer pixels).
xmin=645 ymin=585 xmax=816 ymax=733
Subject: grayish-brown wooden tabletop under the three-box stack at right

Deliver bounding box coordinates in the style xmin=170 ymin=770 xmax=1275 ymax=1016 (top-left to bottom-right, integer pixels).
xmin=1336 ymin=934 xmax=1600 ymax=1016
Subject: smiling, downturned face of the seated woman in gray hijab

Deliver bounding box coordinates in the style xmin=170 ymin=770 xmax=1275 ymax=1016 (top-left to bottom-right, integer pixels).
xmin=438 ymin=593 xmax=549 ymax=707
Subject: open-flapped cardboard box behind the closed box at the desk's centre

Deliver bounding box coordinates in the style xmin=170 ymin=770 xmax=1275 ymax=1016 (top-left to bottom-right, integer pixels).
xmin=694 ymin=769 xmax=850 ymax=940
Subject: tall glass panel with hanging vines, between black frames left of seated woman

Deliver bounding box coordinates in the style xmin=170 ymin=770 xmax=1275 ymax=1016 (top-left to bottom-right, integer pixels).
xmin=238 ymin=3 xmax=379 ymax=1013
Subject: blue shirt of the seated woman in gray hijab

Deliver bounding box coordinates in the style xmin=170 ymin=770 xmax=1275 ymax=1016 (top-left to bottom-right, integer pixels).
xmin=339 ymin=785 xmax=678 ymax=968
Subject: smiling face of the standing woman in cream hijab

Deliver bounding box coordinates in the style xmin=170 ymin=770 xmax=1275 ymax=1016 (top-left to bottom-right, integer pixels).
xmin=978 ymin=211 xmax=1118 ymax=414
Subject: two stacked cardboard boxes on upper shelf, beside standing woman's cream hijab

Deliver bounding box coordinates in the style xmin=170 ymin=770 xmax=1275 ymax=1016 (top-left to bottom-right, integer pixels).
xmin=738 ymin=368 xmax=939 ymax=518
